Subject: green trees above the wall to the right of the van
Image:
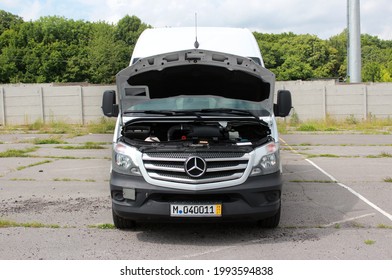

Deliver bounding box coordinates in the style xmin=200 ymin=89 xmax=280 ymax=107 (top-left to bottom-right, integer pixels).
xmin=254 ymin=30 xmax=392 ymax=82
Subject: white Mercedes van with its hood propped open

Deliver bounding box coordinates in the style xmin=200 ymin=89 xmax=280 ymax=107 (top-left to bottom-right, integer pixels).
xmin=102 ymin=28 xmax=291 ymax=229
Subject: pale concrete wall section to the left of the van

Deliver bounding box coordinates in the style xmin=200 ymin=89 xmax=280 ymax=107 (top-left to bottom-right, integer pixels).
xmin=0 ymin=84 xmax=115 ymax=125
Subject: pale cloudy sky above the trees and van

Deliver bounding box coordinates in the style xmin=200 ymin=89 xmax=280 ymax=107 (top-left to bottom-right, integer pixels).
xmin=0 ymin=0 xmax=392 ymax=40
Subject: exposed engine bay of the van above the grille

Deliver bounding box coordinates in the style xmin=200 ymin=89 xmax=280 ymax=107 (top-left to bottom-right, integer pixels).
xmin=121 ymin=119 xmax=271 ymax=145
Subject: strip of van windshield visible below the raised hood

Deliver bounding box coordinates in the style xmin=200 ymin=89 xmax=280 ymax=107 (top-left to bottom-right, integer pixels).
xmin=123 ymin=95 xmax=270 ymax=116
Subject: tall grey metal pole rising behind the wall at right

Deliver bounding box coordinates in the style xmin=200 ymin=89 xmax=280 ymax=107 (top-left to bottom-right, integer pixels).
xmin=347 ymin=0 xmax=362 ymax=83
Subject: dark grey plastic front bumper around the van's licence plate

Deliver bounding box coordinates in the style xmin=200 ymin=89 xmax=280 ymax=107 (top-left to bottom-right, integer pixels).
xmin=110 ymin=171 xmax=282 ymax=222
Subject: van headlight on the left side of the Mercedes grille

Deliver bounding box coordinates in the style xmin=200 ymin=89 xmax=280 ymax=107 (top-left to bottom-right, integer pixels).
xmin=112 ymin=142 xmax=141 ymax=176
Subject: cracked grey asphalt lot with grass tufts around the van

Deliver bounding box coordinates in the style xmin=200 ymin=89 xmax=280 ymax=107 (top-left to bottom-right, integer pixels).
xmin=0 ymin=133 xmax=392 ymax=260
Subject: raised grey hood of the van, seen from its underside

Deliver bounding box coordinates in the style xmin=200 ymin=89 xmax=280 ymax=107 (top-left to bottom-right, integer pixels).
xmin=116 ymin=50 xmax=275 ymax=115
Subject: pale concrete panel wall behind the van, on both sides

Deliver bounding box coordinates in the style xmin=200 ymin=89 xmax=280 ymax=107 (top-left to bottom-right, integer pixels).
xmin=0 ymin=81 xmax=392 ymax=125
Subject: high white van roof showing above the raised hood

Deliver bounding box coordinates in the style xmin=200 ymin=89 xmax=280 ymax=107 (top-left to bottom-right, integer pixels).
xmin=131 ymin=27 xmax=264 ymax=66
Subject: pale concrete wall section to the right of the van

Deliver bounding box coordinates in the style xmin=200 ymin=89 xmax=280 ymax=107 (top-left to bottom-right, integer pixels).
xmin=275 ymin=81 xmax=392 ymax=120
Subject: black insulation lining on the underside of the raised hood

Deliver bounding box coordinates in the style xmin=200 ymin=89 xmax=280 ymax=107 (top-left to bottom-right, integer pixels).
xmin=128 ymin=64 xmax=270 ymax=101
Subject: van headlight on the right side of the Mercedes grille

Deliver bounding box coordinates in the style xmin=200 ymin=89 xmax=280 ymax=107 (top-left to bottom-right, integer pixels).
xmin=250 ymin=143 xmax=280 ymax=176
